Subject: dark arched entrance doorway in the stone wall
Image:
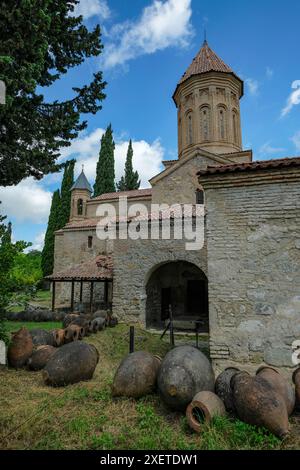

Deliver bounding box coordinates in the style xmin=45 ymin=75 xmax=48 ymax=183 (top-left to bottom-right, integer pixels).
xmin=146 ymin=261 xmax=208 ymax=332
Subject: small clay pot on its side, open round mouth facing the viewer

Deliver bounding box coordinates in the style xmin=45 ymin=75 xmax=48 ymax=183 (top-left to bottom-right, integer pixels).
xmin=186 ymin=392 xmax=226 ymax=432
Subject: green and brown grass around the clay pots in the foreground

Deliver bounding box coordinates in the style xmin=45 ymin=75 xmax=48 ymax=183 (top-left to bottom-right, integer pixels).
xmin=0 ymin=322 xmax=300 ymax=450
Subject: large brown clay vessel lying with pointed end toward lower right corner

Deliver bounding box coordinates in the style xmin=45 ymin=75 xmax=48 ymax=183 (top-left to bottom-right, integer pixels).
xmin=231 ymin=372 xmax=289 ymax=438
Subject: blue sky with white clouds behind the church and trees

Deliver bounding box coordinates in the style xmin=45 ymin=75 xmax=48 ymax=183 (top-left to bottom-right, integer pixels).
xmin=0 ymin=0 xmax=300 ymax=248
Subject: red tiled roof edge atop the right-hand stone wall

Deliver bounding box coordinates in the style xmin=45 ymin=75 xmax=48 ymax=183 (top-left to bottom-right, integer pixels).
xmin=197 ymin=157 xmax=300 ymax=176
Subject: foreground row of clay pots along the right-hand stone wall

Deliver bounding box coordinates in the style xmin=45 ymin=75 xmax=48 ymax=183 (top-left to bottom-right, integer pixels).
xmin=112 ymin=346 xmax=300 ymax=438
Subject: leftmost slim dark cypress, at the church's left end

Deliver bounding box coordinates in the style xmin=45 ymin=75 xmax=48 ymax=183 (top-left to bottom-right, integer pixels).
xmin=42 ymin=189 xmax=61 ymax=276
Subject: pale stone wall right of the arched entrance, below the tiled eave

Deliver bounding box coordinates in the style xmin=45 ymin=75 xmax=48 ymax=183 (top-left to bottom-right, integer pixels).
xmin=200 ymin=169 xmax=300 ymax=368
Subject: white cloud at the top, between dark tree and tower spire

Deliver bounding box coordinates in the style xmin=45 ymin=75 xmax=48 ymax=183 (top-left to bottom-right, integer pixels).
xmin=102 ymin=0 xmax=192 ymax=68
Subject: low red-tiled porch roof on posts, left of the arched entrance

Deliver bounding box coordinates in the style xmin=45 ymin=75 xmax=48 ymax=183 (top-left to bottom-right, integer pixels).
xmin=46 ymin=255 xmax=113 ymax=281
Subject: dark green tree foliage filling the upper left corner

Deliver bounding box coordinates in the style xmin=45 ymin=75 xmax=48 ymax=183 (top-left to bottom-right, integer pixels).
xmin=0 ymin=0 xmax=106 ymax=186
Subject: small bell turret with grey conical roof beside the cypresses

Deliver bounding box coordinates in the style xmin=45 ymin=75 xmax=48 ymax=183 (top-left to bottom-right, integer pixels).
xmin=70 ymin=166 xmax=93 ymax=221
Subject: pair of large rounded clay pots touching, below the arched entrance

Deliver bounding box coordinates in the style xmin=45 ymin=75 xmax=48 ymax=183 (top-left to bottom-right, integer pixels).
xmin=112 ymin=346 xmax=214 ymax=410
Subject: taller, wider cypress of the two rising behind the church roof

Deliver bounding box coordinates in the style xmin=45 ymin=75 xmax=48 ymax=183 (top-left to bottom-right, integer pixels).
xmin=94 ymin=124 xmax=116 ymax=197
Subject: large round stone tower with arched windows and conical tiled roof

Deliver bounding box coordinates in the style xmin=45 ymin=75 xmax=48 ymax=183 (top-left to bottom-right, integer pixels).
xmin=173 ymin=40 xmax=243 ymax=158
